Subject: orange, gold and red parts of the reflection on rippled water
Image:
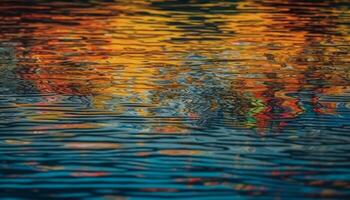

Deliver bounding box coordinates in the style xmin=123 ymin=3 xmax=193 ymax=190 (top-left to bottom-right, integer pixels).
xmin=2 ymin=0 xmax=349 ymax=133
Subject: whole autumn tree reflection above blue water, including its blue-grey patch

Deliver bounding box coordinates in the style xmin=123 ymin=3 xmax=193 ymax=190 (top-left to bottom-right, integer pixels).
xmin=0 ymin=0 xmax=349 ymax=132
